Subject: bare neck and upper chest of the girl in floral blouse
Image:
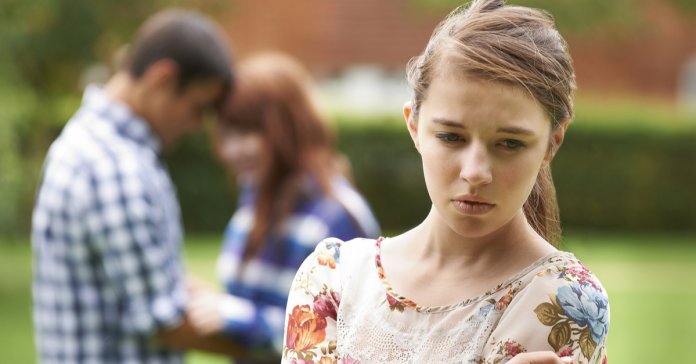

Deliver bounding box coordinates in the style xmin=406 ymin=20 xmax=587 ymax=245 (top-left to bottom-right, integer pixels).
xmin=380 ymin=209 xmax=555 ymax=306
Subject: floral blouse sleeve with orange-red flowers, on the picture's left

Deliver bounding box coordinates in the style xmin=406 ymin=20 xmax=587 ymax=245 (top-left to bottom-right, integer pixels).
xmin=282 ymin=238 xmax=343 ymax=363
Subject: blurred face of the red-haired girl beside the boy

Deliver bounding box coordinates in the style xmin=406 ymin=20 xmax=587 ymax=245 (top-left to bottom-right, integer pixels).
xmin=215 ymin=123 xmax=271 ymax=185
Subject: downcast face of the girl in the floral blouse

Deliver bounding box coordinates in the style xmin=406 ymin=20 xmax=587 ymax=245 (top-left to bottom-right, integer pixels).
xmin=404 ymin=76 xmax=567 ymax=238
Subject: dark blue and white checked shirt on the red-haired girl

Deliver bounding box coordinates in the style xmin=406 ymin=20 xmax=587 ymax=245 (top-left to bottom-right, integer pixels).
xmin=217 ymin=177 xmax=380 ymax=357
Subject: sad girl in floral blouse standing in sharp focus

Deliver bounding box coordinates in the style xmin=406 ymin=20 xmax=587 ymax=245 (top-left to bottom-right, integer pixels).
xmin=283 ymin=0 xmax=609 ymax=364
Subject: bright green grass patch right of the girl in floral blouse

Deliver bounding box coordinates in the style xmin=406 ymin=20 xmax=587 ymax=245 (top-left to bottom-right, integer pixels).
xmin=566 ymin=233 xmax=696 ymax=364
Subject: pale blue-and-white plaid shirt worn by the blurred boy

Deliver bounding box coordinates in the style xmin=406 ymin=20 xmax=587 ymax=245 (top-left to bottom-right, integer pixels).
xmin=32 ymin=86 xmax=186 ymax=364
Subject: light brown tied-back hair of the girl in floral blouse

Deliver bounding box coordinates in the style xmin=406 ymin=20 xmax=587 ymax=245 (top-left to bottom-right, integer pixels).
xmin=408 ymin=0 xmax=575 ymax=245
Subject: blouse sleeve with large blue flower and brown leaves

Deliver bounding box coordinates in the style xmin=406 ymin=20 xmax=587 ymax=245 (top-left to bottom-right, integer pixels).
xmin=483 ymin=263 xmax=609 ymax=364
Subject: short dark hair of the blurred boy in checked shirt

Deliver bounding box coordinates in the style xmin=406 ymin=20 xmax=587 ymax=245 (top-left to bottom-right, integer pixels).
xmin=122 ymin=9 xmax=232 ymax=90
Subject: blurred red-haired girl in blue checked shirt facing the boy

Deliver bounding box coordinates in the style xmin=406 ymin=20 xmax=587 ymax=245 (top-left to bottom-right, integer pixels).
xmin=190 ymin=54 xmax=379 ymax=363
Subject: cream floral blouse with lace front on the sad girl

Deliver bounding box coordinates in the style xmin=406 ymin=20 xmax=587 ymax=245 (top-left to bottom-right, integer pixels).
xmin=282 ymin=238 xmax=609 ymax=364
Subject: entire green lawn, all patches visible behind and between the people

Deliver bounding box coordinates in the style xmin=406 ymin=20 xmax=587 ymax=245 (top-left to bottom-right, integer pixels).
xmin=0 ymin=232 xmax=696 ymax=364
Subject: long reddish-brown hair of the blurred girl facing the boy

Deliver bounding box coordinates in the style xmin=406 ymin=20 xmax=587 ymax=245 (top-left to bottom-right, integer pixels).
xmin=218 ymin=53 xmax=334 ymax=259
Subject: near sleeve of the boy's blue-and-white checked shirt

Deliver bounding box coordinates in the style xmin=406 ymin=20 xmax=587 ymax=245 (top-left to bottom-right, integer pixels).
xmin=85 ymin=163 xmax=186 ymax=335
